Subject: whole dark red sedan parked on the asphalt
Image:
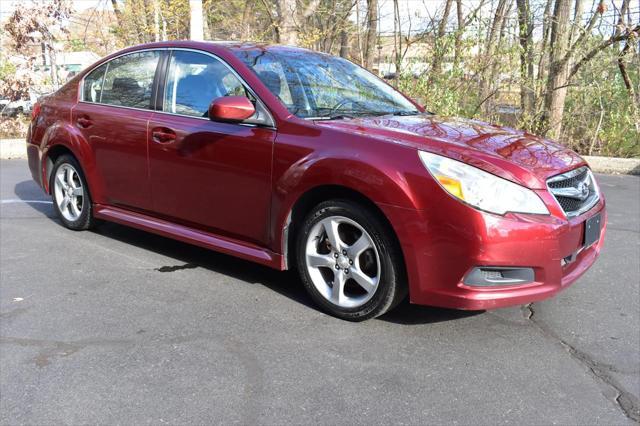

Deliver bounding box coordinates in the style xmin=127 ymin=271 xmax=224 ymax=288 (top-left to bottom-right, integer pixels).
xmin=27 ymin=42 xmax=606 ymax=320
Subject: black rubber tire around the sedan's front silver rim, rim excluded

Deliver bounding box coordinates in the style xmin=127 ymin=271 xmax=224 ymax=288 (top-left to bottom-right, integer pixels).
xmin=295 ymin=200 xmax=407 ymax=321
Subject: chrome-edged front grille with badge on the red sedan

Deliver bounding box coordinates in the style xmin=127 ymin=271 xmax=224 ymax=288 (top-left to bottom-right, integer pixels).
xmin=547 ymin=166 xmax=600 ymax=217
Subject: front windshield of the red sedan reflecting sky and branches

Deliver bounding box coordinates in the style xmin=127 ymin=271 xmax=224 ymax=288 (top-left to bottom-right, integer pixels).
xmin=234 ymin=48 xmax=420 ymax=119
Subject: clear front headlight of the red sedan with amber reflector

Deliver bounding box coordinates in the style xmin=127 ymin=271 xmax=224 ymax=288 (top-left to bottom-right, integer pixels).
xmin=418 ymin=151 xmax=549 ymax=215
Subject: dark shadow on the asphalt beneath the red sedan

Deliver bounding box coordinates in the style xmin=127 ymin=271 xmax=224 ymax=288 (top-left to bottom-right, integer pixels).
xmin=14 ymin=181 xmax=480 ymax=325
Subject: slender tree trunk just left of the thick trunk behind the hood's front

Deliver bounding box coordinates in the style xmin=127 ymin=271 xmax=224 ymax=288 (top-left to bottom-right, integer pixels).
xmin=516 ymin=0 xmax=535 ymax=118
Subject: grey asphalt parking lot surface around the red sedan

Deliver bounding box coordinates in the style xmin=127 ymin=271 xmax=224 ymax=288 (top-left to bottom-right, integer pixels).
xmin=0 ymin=160 xmax=640 ymax=424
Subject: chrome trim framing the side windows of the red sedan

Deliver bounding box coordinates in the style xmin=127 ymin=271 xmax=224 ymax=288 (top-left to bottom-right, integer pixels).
xmin=78 ymin=47 xmax=276 ymax=130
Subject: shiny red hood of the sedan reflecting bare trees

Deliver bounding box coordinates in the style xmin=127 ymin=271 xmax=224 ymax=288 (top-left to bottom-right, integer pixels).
xmin=317 ymin=114 xmax=584 ymax=189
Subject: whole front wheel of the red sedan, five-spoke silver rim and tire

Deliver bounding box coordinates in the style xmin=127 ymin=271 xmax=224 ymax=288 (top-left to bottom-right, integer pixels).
xmin=296 ymin=200 xmax=406 ymax=321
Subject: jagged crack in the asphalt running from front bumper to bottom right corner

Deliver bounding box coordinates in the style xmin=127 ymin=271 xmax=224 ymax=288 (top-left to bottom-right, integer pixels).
xmin=521 ymin=303 xmax=640 ymax=422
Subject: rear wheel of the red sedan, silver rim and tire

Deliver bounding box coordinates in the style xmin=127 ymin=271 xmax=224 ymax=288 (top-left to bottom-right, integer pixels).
xmin=49 ymin=154 xmax=94 ymax=231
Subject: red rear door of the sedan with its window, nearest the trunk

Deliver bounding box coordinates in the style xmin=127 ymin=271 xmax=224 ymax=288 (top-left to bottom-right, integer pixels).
xmin=72 ymin=50 xmax=161 ymax=210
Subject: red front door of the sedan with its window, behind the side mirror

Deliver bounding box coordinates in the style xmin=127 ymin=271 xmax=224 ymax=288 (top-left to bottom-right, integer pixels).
xmin=149 ymin=50 xmax=275 ymax=244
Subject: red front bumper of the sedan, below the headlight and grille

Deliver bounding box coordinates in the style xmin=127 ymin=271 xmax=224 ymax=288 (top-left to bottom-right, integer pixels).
xmin=380 ymin=191 xmax=606 ymax=310
